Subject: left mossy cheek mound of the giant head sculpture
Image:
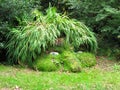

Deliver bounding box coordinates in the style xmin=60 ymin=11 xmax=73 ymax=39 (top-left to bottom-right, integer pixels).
xmin=33 ymin=54 xmax=60 ymax=71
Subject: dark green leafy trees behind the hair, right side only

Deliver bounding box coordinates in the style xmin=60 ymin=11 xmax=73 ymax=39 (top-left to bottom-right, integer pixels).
xmin=42 ymin=0 xmax=120 ymax=42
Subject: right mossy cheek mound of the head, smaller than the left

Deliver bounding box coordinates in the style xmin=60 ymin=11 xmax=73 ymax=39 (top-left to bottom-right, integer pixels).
xmin=76 ymin=52 xmax=96 ymax=67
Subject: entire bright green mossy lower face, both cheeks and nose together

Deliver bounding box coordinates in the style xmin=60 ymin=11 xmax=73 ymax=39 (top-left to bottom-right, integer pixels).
xmin=33 ymin=50 xmax=96 ymax=72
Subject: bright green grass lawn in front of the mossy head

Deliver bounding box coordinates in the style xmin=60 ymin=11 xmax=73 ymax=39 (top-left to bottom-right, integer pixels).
xmin=0 ymin=57 xmax=120 ymax=90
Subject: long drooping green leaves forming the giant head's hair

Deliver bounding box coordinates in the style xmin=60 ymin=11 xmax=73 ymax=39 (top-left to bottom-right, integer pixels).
xmin=6 ymin=7 xmax=97 ymax=63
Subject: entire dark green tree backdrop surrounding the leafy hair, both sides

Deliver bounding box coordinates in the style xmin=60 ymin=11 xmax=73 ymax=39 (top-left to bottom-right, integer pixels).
xmin=0 ymin=0 xmax=120 ymax=60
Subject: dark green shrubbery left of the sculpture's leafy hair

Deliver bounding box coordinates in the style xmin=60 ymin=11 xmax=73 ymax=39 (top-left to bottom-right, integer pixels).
xmin=0 ymin=0 xmax=40 ymax=60
